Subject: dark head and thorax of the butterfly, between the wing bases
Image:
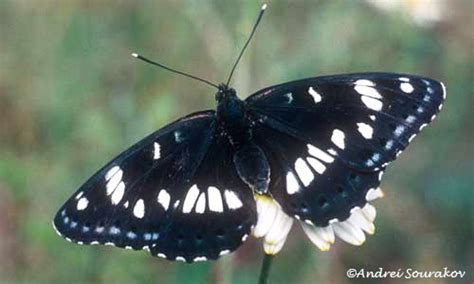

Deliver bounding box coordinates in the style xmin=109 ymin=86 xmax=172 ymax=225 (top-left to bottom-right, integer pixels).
xmin=216 ymin=84 xmax=250 ymax=147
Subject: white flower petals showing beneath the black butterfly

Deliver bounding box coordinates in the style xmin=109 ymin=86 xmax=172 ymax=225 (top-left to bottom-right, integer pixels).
xmin=252 ymin=188 xmax=383 ymax=255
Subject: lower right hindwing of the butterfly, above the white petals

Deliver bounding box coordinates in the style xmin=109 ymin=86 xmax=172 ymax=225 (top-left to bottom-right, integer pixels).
xmin=255 ymin=123 xmax=380 ymax=226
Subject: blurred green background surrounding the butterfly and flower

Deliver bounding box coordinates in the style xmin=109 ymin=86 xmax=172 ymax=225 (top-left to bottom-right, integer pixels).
xmin=0 ymin=0 xmax=474 ymax=283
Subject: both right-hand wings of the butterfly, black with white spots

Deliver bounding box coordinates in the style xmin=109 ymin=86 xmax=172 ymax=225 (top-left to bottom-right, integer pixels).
xmin=246 ymin=73 xmax=445 ymax=226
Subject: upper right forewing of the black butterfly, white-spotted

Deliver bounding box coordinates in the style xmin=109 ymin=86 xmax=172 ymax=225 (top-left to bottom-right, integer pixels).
xmin=246 ymin=73 xmax=445 ymax=170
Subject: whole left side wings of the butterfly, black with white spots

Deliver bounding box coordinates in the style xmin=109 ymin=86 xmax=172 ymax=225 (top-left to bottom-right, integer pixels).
xmin=54 ymin=111 xmax=256 ymax=262
